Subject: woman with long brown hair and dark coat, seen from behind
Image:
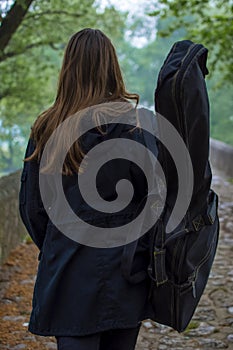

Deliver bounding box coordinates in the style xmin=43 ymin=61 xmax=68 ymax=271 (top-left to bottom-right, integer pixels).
xmin=20 ymin=29 xmax=154 ymax=350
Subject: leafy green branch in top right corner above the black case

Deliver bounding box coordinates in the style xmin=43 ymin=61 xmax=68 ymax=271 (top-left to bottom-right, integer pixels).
xmin=151 ymin=0 xmax=233 ymax=82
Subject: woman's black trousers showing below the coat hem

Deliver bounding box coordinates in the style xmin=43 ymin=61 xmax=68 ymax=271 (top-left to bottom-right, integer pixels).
xmin=56 ymin=324 xmax=141 ymax=350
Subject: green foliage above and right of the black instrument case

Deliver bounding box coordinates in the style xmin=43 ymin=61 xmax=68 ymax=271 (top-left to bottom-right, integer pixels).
xmin=147 ymin=0 xmax=233 ymax=145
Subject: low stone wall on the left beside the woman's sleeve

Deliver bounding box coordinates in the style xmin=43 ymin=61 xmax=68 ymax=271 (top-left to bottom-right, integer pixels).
xmin=0 ymin=171 xmax=26 ymax=263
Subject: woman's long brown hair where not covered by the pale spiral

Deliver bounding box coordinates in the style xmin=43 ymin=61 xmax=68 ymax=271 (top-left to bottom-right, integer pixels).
xmin=25 ymin=28 xmax=139 ymax=175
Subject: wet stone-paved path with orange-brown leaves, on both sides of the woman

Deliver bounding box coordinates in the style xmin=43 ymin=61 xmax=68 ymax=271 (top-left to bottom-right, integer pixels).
xmin=0 ymin=169 xmax=233 ymax=350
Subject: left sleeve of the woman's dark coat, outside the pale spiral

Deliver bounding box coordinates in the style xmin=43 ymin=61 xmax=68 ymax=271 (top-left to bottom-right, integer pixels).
xmin=19 ymin=139 xmax=49 ymax=250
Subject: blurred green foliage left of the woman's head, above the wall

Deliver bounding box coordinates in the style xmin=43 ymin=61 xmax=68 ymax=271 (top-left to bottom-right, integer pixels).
xmin=0 ymin=0 xmax=124 ymax=173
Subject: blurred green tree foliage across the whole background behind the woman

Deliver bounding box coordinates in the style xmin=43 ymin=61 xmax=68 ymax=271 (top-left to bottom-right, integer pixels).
xmin=0 ymin=0 xmax=233 ymax=173
